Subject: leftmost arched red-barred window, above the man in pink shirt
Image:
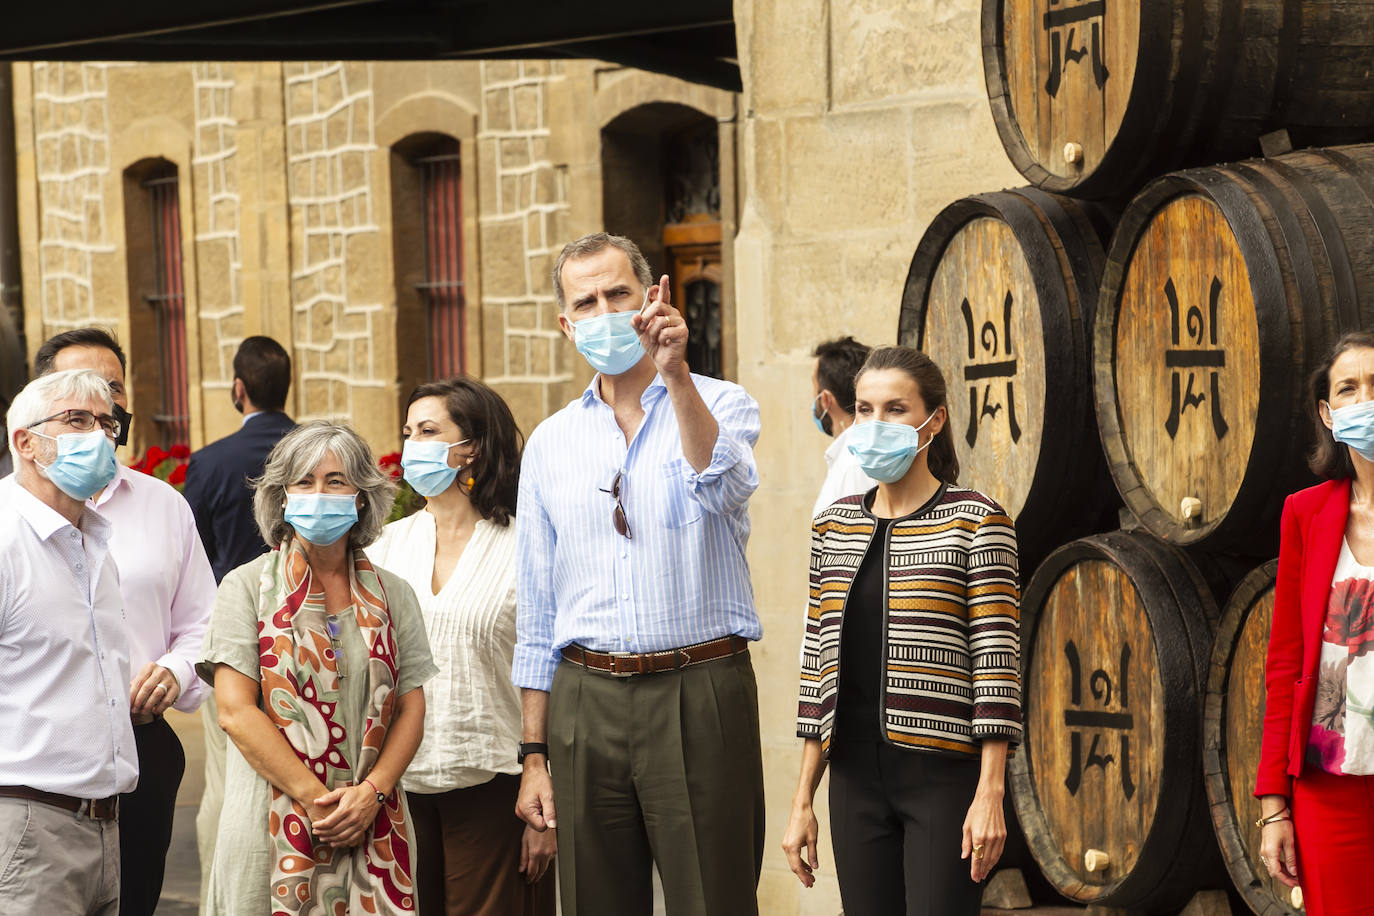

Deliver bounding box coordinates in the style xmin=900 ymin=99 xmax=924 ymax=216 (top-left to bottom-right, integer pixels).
xmin=124 ymin=159 xmax=191 ymax=448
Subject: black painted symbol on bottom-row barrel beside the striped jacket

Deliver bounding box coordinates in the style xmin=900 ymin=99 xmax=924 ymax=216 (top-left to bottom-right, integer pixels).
xmin=1063 ymin=640 xmax=1135 ymax=801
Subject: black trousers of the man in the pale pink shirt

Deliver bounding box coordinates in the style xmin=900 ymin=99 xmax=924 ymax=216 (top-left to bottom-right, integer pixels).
xmin=120 ymin=717 xmax=185 ymax=916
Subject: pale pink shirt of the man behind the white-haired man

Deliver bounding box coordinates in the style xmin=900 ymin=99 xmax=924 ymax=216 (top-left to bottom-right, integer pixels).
xmin=87 ymin=464 xmax=214 ymax=713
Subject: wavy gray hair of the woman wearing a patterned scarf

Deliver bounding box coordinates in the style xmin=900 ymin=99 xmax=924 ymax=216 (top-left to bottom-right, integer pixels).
xmin=251 ymin=420 xmax=396 ymax=547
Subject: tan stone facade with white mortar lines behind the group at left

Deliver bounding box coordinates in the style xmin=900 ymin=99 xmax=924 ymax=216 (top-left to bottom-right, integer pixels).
xmin=15 ymin=60 xmax=735 ymax=450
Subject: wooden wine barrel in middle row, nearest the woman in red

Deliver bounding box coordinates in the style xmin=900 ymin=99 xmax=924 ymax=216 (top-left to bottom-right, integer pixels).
xmin=1094 ymin=144 xmax=1374 ymax=556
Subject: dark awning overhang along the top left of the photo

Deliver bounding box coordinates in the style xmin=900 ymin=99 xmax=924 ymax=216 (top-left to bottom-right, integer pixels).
xmin=0 ymin=0 xmax=741 ymax=92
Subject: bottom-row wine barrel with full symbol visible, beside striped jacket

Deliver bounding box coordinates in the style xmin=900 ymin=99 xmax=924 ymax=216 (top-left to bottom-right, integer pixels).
xmin=1010 ymin=531 xmax=1226 ymax=913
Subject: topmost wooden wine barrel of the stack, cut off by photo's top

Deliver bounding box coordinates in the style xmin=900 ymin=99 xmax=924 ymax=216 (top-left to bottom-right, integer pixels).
xmin=982 ymin=0 xmax=1374 ymax=198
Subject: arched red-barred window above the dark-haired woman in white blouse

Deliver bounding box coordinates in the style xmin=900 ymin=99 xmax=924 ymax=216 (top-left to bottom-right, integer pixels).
xmin=392 ymin=133 xmax=467 ymax=384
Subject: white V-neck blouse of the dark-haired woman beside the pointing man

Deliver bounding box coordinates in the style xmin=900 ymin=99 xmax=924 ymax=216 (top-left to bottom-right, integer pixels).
xmin=367 ymin=509 xmax=521 ymax=792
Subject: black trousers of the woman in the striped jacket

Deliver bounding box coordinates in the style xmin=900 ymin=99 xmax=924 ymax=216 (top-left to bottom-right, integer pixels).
xmin=830 ymin=742 xmax=982 ymax=916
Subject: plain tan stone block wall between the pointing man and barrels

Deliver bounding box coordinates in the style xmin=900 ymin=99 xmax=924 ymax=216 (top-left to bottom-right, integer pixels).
xmin=735 ymin=0 xmax=1025 ymax=916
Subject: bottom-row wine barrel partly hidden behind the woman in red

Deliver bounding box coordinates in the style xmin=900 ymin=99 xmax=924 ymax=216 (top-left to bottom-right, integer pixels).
xmin=1202 ymin=560 xmax=1301 ymax=916
